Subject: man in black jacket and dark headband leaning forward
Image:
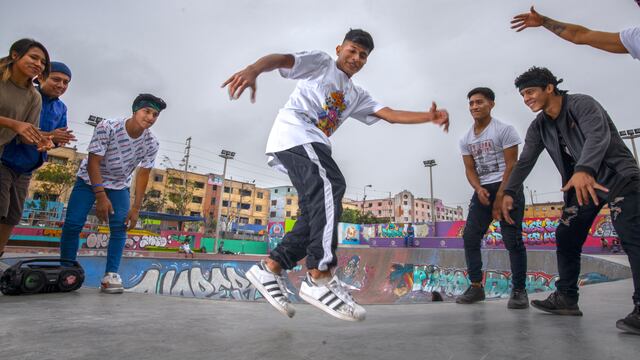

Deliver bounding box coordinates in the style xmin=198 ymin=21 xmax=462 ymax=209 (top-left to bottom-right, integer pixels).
xmin=502 ymin=67 xmax=640 ymax=334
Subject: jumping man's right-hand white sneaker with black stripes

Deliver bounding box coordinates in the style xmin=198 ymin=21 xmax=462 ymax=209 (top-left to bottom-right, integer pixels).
xmin=300 ymin=273 xmax=367 ymax=321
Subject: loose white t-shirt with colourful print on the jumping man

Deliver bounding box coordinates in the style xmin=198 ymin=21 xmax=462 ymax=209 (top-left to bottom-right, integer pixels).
xmin=266 ymin=51 xmax=384 ymax=172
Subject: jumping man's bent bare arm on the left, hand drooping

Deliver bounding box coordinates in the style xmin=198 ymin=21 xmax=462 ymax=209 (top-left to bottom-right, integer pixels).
xmin=222 ymin=54 xmax=295 ymax=102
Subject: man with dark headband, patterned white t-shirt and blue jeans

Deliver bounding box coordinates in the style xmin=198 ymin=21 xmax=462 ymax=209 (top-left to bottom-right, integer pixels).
xmin=60 ymin=94 xmax=167 ymax=294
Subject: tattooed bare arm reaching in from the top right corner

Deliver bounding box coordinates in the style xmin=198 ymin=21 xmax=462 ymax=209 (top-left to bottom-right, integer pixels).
xmin=511 ymin=6 xmax=629 ymax=54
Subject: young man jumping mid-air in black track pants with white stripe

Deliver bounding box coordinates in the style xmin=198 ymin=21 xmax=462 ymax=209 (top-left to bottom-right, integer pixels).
xmin=222 ymin=30 xmax=449 ymax=321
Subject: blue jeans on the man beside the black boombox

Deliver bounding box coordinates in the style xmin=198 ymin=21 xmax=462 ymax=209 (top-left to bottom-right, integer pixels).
xmin=60 ymin=178 xmax=130 ymax=272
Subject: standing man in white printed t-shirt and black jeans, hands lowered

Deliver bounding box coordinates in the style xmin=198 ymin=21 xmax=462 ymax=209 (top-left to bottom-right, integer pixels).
xmin=456 ymin=87 xmax=529 ymax=309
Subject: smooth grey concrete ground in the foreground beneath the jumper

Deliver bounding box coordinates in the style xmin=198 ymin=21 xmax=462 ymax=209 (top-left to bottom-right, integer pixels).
xmin=0 ymin=280 xmax=640 ymax=360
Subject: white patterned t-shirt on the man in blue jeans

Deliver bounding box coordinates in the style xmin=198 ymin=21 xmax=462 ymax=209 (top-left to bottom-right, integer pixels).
xmin=78 ymin=119 xmax=160 ymax=190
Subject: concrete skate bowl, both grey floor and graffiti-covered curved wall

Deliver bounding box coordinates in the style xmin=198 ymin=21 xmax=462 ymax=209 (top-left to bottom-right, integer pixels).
xmin=0 ymin=248 xmax=640 ymax=360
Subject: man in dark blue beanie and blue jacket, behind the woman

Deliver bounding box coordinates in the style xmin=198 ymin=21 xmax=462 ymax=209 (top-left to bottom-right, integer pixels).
xmin=38 ymin=61 xmax=76 ymax=146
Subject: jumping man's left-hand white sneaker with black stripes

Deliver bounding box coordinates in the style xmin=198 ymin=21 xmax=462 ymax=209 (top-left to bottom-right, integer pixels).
xmin=246 ymin=261 xmax=296 ymax=317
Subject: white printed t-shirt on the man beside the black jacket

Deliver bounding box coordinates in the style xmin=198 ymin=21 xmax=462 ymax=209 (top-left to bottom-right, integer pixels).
xmin=460 ymin=118 xmax=522 ymax=185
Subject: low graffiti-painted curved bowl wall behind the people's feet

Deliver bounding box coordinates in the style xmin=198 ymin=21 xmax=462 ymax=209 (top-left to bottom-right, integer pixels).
xmin=3 ymin=248 xmax=631 ymax=304
